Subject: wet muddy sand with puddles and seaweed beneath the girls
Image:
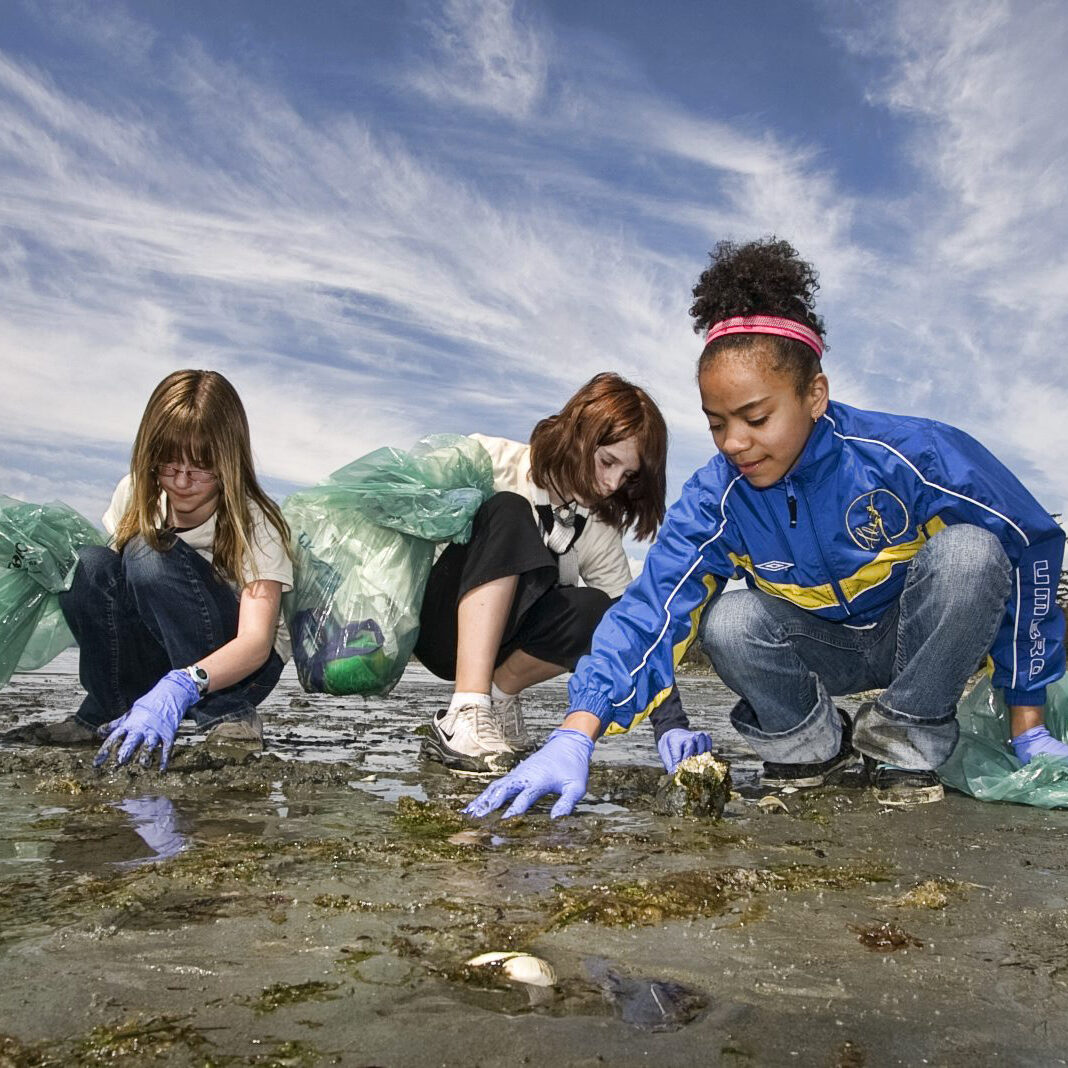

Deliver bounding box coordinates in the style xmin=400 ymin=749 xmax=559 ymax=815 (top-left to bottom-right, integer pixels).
xmin=0 ymin=655 xmax=1068 ymax=1066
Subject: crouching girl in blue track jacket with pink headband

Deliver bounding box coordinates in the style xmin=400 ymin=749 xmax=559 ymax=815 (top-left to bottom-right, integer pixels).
xmin=469 ymin=238 xmax=1068 ymax=816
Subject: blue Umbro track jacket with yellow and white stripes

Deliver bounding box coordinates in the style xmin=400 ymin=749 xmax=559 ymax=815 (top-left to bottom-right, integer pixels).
xmin=569 ymin=404 xmax=1065 ymax=733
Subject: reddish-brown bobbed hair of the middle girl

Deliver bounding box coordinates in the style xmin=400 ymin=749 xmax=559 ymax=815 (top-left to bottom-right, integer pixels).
xmin=531 ymin=372 xmax=668 ymax=540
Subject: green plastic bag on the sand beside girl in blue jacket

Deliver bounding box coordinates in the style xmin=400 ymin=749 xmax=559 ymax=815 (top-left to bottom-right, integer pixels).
xmin=938 ymin=675 xmax=1068 ymax=808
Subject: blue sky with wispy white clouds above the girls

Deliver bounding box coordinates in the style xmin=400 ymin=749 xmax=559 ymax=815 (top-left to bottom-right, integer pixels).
xmin=0 ymin=0 xmax=1068 ymax=546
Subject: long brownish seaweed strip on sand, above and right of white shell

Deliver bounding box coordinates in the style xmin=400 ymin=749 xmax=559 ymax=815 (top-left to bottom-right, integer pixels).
xmin=548 ymin=864 xmax=889 ymax=928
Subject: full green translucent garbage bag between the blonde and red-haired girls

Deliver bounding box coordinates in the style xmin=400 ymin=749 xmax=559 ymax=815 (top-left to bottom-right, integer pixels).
xmin=282 ymin=435 xmax=493 ymax=694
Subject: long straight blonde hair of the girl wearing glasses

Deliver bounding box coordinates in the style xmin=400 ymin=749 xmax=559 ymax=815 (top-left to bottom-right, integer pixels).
xmin=115 ymin=371 xmax=292 ymax=585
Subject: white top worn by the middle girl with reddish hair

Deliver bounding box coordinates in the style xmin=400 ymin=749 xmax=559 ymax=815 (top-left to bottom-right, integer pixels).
xmin=469 ymin=434 xmax=631 ymax=597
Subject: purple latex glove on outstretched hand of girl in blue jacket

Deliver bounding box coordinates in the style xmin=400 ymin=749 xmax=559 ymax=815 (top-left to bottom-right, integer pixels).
xmin=464 ymin=727 xmax=594 ymax=819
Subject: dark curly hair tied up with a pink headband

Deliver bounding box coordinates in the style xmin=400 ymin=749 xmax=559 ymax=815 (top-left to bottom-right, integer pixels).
xmin=690 ymin=235 xmax=824 ymax=395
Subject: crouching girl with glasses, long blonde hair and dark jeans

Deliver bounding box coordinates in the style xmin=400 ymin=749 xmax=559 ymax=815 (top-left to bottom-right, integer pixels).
xmin=11 ymin=371 xmax=293 ymax=770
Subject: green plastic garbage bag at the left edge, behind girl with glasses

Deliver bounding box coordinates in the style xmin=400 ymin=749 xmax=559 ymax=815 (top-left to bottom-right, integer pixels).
xmin=0 ymin=496 xmax=104 ymax=686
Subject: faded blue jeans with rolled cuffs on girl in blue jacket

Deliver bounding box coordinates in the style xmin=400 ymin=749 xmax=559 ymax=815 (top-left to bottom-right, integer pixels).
xmin=700 ymin=524 xmax=1011 ymax=769
